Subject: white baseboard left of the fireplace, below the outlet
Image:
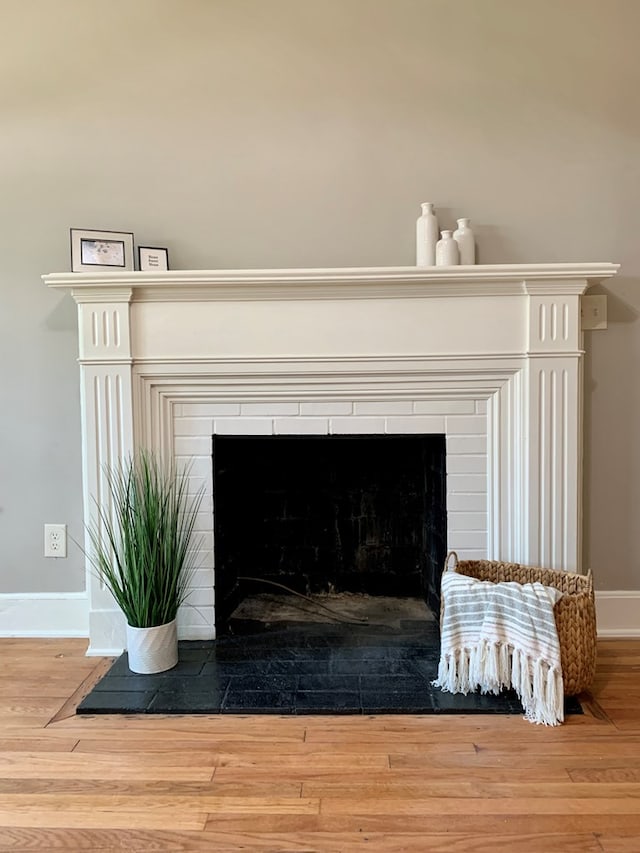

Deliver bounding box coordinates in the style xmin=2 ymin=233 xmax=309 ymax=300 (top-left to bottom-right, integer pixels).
xmin=0 ymin=592 xmax=89 ymax=637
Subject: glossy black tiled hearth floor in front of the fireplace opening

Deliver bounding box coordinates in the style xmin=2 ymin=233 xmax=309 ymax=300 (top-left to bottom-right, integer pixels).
xmin=77 ymin=620 xmax=582 ymax=714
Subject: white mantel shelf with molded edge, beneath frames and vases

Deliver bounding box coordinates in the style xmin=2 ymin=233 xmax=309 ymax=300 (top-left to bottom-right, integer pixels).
xmin=42 ymin=263 xmax=618 ymax=302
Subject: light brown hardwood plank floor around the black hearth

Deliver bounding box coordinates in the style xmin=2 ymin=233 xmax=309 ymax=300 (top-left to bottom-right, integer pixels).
xmin=0 ymin=640 xmax=640 ymax=853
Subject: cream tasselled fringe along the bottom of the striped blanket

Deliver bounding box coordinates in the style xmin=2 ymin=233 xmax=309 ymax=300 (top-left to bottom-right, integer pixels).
xmin=432 ymin=640 xmax=564 ymax=726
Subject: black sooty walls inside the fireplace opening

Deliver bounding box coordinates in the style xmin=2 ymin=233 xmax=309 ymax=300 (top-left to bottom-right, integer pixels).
xmin=213 ymin=435 xmax=447 ymax=632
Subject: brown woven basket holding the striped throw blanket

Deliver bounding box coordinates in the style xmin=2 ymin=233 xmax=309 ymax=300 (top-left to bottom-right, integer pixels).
xmin=441 ymin=551 xmax=596 ymax=696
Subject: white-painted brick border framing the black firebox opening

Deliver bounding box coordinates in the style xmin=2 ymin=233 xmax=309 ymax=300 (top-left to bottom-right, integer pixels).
xmin=174 ymin=400 xmax=487 ymax=636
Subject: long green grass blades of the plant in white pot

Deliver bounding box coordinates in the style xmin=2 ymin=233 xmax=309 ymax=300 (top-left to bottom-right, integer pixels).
xmin=89 ymin=451 xmax=202 ymax=628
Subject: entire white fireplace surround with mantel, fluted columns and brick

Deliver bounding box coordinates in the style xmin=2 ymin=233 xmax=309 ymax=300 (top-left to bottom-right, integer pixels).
xmin=44 ymin=263 xmax=617 ymax=654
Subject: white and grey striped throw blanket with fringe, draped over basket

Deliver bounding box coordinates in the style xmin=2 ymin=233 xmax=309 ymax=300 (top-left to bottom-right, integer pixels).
xmin=433 ymin=571 xmax=564 ymax=726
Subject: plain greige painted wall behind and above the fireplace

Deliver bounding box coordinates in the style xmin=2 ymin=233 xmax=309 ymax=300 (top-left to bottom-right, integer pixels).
xmin=0 ymin=0 xmax=640 ymax=592
